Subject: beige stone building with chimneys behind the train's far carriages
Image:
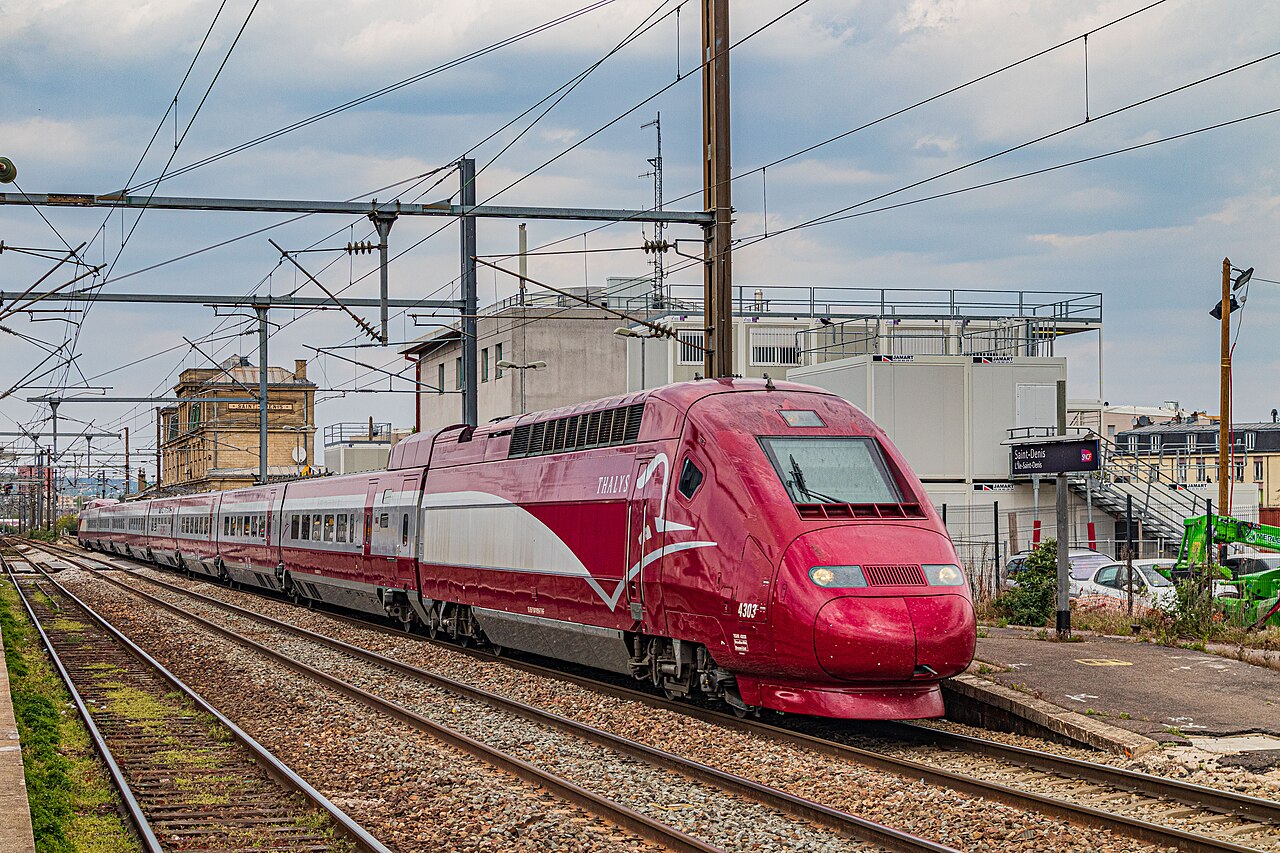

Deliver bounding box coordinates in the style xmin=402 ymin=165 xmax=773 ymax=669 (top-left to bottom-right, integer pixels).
xmin=156 ymin=356 xmax=316 ymax=494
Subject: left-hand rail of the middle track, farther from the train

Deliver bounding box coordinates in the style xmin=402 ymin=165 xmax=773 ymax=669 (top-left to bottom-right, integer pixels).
xmin=24 ymin=543 xmax=732 ymax=853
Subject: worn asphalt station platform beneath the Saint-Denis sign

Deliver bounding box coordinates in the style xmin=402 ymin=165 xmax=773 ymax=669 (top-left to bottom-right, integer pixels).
xmin=961 ymin=628 xmax=1280 ymax=748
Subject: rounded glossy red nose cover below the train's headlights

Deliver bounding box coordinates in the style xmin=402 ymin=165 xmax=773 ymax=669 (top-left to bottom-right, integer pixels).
xmin=813 ymin=594 xmax=977 ymax=681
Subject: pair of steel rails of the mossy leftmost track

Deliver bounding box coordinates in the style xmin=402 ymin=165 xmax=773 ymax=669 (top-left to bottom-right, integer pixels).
xmin=0 ymin=540 xmax=392 ymax=853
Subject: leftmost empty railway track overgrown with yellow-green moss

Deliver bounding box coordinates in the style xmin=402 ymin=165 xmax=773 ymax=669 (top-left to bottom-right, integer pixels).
xmin=5 ymin=540 xmax=388 ymax=853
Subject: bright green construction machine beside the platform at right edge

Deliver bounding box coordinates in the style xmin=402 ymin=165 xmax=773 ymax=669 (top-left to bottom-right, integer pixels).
xmin=1170 ymin=515 xmax=1280 ymax=630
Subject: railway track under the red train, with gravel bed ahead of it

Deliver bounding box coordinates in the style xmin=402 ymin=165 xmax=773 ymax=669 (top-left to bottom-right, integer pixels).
xmin=27 ymin=537 xmax=1280 ymax=852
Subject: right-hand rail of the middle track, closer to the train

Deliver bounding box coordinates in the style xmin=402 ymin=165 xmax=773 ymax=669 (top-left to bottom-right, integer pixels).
xmin=60 ymin=550 xmax=955 ymax=853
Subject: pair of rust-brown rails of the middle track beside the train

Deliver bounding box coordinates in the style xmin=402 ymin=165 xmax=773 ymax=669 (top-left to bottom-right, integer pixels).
xmin=12 ymin=544 xmax=955 ymax=853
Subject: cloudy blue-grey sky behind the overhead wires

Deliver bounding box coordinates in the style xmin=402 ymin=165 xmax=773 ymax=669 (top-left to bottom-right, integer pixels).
xmin=0 ymin=0 xmax=1280 ymax=471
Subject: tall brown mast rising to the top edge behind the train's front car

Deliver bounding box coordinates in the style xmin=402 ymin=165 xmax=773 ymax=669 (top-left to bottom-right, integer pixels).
xmin=703 ymin=0 xmax=733 ymax=378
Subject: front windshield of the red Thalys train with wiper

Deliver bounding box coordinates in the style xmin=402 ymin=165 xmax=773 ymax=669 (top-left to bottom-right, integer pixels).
xmin=760 ymin=435 xmax=902 ymax=503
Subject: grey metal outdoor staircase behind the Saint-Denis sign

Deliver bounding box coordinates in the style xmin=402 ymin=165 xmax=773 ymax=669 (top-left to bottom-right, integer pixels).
xmin=1068 ymin=437 xmax=1206 ymax=547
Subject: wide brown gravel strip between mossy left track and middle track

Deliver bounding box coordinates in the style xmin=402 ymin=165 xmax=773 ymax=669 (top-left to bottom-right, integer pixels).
xmin=59 ymin=570 xmax=659 ymax=853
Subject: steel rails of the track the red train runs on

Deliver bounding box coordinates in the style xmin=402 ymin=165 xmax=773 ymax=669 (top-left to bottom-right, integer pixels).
xmin=42 ymin=537 xmax=1280 ymax=853
